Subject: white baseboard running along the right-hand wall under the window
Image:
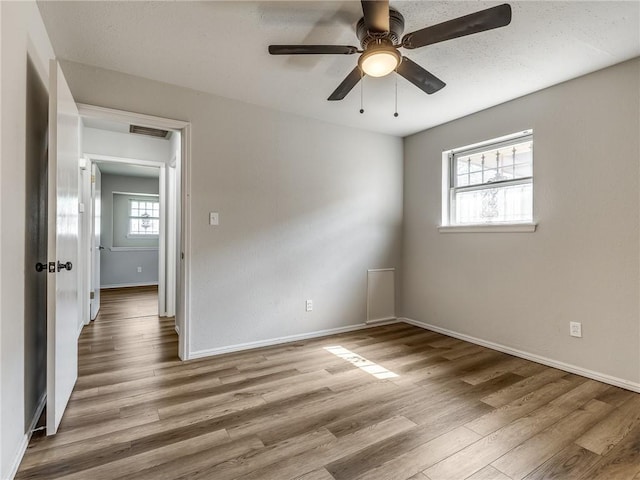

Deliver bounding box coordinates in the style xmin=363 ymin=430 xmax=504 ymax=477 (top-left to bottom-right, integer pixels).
xmin=398 ymin=317 xmax=640 ymax=393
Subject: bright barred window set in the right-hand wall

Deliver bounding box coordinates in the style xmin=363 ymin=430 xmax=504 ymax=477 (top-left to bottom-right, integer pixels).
xmin=443 ymin=131 xmax=533 ymax=226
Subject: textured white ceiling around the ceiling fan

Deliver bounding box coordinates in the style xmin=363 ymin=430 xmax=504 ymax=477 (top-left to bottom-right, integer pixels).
xmin=39 ymin=0 xmax=640 ymax=136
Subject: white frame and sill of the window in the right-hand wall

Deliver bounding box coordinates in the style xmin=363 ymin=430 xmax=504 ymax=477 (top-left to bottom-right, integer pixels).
xmin=439 ymin=130 xmax=537 ymax=233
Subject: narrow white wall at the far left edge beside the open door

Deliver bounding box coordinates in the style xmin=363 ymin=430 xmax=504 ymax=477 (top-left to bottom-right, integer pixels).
xmin=0 ymin=2 xmax=53 ymax=480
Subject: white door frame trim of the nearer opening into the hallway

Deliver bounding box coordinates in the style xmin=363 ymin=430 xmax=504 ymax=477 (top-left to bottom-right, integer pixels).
xmin=77 ymin=103 xmax=191 ymax=360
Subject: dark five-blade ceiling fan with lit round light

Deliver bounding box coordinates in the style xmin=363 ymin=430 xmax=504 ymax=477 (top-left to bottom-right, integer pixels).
xmin=269 ymin=0 xmax=511 ymax=100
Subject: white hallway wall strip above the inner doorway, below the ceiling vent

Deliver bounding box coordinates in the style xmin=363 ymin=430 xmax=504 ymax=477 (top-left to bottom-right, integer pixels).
xmin=82 ymin=127 xmax=173 ymax=163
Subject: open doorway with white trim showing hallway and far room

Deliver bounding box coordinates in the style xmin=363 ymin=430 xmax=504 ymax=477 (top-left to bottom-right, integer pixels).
xmin=78 ymin=105 xmax=189 ymax=360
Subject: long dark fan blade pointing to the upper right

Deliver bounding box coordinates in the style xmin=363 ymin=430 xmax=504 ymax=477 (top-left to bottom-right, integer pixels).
xmin=402 ymin=3 xmax=511 ymax=49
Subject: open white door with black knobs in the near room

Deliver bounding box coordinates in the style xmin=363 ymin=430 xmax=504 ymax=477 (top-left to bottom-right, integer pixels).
xmin=47 ymin=60 xmax=80 ymax=435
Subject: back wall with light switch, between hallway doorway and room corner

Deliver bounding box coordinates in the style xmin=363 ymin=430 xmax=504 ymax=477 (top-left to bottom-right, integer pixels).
xmin=58 ymin=62 xmax=402 ymax=353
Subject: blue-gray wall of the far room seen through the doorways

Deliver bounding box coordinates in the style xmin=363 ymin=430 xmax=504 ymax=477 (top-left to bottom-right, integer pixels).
xmin=100 ymin=173 xmax=159 ymax=287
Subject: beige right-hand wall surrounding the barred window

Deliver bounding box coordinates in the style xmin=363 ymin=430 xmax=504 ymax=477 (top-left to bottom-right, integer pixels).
xmin=402 ymin=59 xmax=640 ymax=388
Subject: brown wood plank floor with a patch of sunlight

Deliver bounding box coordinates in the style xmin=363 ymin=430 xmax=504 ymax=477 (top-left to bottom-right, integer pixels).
xmin=17 ymin=288 xmax=640 ymax=480
